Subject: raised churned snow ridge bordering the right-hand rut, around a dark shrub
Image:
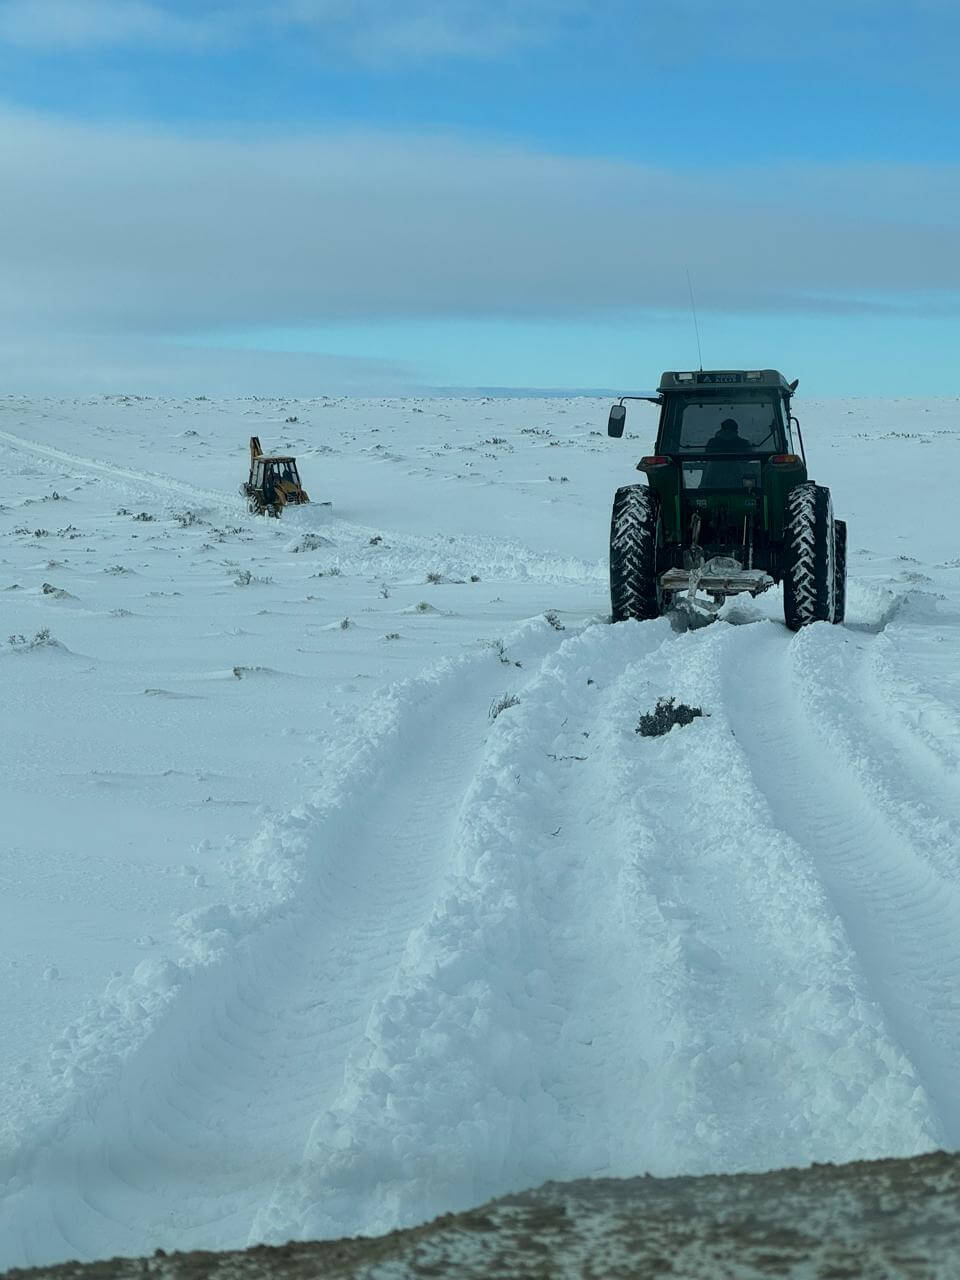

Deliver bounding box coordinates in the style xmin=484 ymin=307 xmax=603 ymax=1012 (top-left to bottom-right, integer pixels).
xmin=593 ymin=622 xmax=936 ymax=1172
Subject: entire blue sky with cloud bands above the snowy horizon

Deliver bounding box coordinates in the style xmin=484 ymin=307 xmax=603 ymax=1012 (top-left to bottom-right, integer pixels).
xmin=0 ymin=0 xmax=960 ymax=396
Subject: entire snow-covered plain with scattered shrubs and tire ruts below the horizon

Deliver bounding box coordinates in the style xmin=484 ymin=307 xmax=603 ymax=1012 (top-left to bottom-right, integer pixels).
xmin=0 ymin=397 xmax=960 ymax=1268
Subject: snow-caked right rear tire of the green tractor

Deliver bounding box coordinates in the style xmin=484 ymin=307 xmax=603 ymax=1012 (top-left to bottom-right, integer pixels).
xmin=783 ymin=481 xmax=836 ymax=631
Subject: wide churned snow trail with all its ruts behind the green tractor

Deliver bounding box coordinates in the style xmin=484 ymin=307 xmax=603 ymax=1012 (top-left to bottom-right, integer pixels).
xmin=0 ymin=609 xmax=960 ymax=1265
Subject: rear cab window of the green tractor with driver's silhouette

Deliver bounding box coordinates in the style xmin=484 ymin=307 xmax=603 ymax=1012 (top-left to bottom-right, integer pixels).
xmin=658 ymin=390 xmax=783 ymax=453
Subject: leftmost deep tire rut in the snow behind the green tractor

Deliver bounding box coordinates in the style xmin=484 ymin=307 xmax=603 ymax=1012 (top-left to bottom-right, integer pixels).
xmin=0 ymin=622 xmax=557 ymax=1266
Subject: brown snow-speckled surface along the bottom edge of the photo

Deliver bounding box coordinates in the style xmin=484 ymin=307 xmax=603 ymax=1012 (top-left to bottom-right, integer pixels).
xmin=5 ymin=1152 xmax=960 ymax=1280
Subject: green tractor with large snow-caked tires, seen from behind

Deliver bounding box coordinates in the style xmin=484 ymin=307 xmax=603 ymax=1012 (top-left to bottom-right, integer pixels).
xmin=607 ymin=369 xmax=846 ymax=631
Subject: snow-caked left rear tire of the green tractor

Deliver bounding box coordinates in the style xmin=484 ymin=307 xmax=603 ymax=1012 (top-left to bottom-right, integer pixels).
xmin=611 ymin=484 xmax=663 ymax=622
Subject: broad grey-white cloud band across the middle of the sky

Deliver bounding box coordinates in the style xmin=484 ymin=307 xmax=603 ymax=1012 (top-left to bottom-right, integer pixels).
xmin=0 ymin=111 xmax=960 ymax=368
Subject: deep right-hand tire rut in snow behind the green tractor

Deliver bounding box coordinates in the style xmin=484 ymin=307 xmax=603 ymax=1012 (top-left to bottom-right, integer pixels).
xmin=726 ymin=626 xmax=960 ymax=1147
